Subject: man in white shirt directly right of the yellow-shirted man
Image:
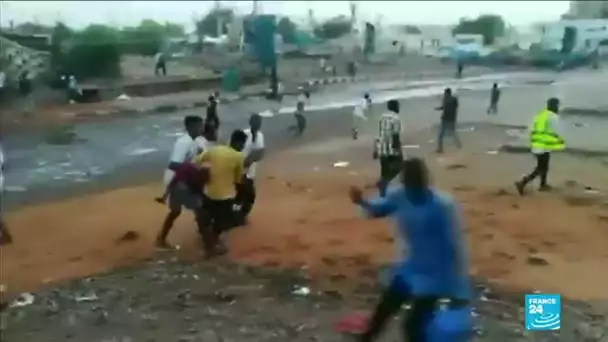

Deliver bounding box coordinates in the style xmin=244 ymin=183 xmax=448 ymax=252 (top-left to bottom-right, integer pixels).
xmin=236 ymin=114 xmax=266 ymax=225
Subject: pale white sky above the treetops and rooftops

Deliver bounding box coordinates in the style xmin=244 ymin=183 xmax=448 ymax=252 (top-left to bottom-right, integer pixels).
xmin=0 ymin=1 xmax=569 ymax=27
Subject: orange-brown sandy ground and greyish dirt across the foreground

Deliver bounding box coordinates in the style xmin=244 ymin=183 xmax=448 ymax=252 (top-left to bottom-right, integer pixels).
xmin=2 ymin=126 xmax=608 ymax=342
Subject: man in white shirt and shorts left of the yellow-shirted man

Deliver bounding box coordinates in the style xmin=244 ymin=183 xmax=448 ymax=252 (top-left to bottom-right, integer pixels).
xmin=156 ymin=115 xmax=206 ymax=248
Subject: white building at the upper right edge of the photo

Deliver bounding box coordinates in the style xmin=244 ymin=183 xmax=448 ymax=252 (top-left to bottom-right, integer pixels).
xmin=536 ymin=19 xmax=608 ymax=51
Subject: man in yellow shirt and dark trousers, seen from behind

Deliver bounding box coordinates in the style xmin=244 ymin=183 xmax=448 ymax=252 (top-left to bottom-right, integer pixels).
xmin=193 ymin=130 xmax=247 ymax=256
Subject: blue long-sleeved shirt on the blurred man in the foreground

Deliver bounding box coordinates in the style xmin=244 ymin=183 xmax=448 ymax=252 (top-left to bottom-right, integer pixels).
xmin=360 ymin=186 xmax=471 ymax=299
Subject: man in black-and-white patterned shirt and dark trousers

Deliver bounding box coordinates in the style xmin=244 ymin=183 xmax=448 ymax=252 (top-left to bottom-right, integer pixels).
xmin=374 ymin=100 xmax=403 ymax=196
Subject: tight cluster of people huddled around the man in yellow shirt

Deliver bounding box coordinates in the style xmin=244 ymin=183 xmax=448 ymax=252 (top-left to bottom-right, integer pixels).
xmin=156 ymin=93 xmax=265 ymax=257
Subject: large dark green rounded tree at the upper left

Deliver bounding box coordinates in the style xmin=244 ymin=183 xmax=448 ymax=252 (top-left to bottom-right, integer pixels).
xmin=65 ymin=25 xmax=121 ymax=79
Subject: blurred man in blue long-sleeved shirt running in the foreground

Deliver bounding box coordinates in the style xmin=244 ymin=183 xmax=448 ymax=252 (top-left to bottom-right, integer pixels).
xmin=350 ymin=158 xmax=471 ymax=342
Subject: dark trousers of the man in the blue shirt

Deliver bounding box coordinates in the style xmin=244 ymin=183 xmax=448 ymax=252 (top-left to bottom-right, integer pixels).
xmin=358 ymin=278 xmax=438 ymax=342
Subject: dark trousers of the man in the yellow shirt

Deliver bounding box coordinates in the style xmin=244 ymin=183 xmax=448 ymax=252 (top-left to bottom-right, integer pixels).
xmin=197 ymin=197 xmax=235 ymax=251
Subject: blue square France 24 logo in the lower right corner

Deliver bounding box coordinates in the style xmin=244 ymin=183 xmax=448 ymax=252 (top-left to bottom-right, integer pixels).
xmin=524 ymin=294 xmax=562 ymax=331
